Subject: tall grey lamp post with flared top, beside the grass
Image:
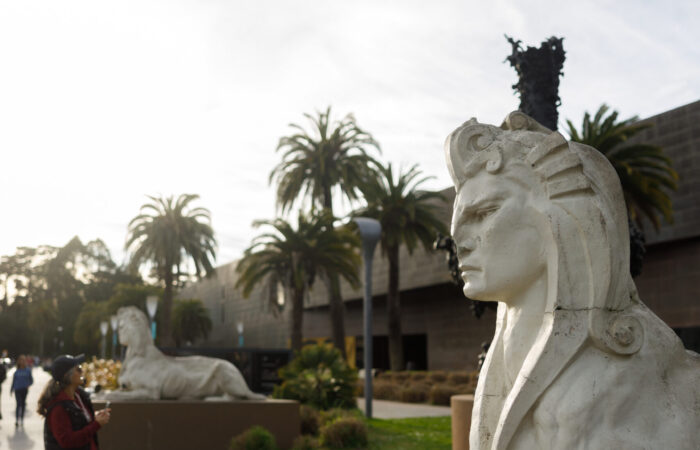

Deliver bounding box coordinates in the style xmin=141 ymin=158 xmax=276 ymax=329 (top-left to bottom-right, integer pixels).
xmin=354 ymin=217 xmax=382 ymax=418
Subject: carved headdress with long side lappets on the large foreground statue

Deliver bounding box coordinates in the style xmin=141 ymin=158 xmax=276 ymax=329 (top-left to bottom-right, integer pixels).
xmin=445 ymin=112 xmax=696 ymax=449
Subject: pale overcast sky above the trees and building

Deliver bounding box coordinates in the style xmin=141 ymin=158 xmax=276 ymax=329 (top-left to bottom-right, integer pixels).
xmin=0 ymin=0 xmax=700 ymax=264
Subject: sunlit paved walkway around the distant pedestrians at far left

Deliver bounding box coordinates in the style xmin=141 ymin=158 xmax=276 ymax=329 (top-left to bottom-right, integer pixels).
xmin=0 ymin=367 xmax=51 ymax=450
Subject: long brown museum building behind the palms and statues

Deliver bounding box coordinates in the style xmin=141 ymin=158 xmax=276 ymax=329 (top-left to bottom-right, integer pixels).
xmin=178 ymin=101 xmax=700 ymax=370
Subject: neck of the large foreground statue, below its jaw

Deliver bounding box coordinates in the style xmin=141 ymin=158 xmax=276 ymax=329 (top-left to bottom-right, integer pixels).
xmin=503 ymin=274 xmax=547 ymax=386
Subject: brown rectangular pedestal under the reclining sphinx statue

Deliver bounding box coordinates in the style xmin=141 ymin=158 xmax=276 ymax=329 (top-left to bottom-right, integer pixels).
xmin=94 ymin=400 xmax=301 ymax=450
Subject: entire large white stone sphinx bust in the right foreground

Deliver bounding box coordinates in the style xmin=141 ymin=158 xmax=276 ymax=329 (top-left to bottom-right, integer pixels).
xmin=445 ymin=112 xmax=700 ymax=450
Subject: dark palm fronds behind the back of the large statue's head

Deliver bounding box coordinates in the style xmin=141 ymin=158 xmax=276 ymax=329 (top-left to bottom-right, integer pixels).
xmin=566 ymin=104 xmax=678 ymax=230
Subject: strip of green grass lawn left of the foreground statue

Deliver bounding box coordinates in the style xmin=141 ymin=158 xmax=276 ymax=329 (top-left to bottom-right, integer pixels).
xmin=367 ymin=416 xmax=452 ymax=450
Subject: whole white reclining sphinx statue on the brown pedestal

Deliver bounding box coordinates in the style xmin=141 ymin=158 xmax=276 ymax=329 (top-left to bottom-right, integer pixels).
xmin=106 ymin=306 xmax=265 ymax=400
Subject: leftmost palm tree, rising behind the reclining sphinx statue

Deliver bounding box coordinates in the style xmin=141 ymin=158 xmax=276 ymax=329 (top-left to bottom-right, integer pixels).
xmin=125 ymin=194 xmax=216 ymax=345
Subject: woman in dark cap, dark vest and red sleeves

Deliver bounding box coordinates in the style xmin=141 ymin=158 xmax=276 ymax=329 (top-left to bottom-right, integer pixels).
xmin=39 ymin=355 xmax=111 ymax=450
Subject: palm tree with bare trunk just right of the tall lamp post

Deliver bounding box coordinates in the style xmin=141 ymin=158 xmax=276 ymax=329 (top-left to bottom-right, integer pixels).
xmin=353 ymin=164 xmax=447 ymax=370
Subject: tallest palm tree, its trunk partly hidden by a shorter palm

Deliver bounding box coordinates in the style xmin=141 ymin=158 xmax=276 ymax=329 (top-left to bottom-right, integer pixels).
xmin=270 ymin=106 xmax=381 ymax=356
